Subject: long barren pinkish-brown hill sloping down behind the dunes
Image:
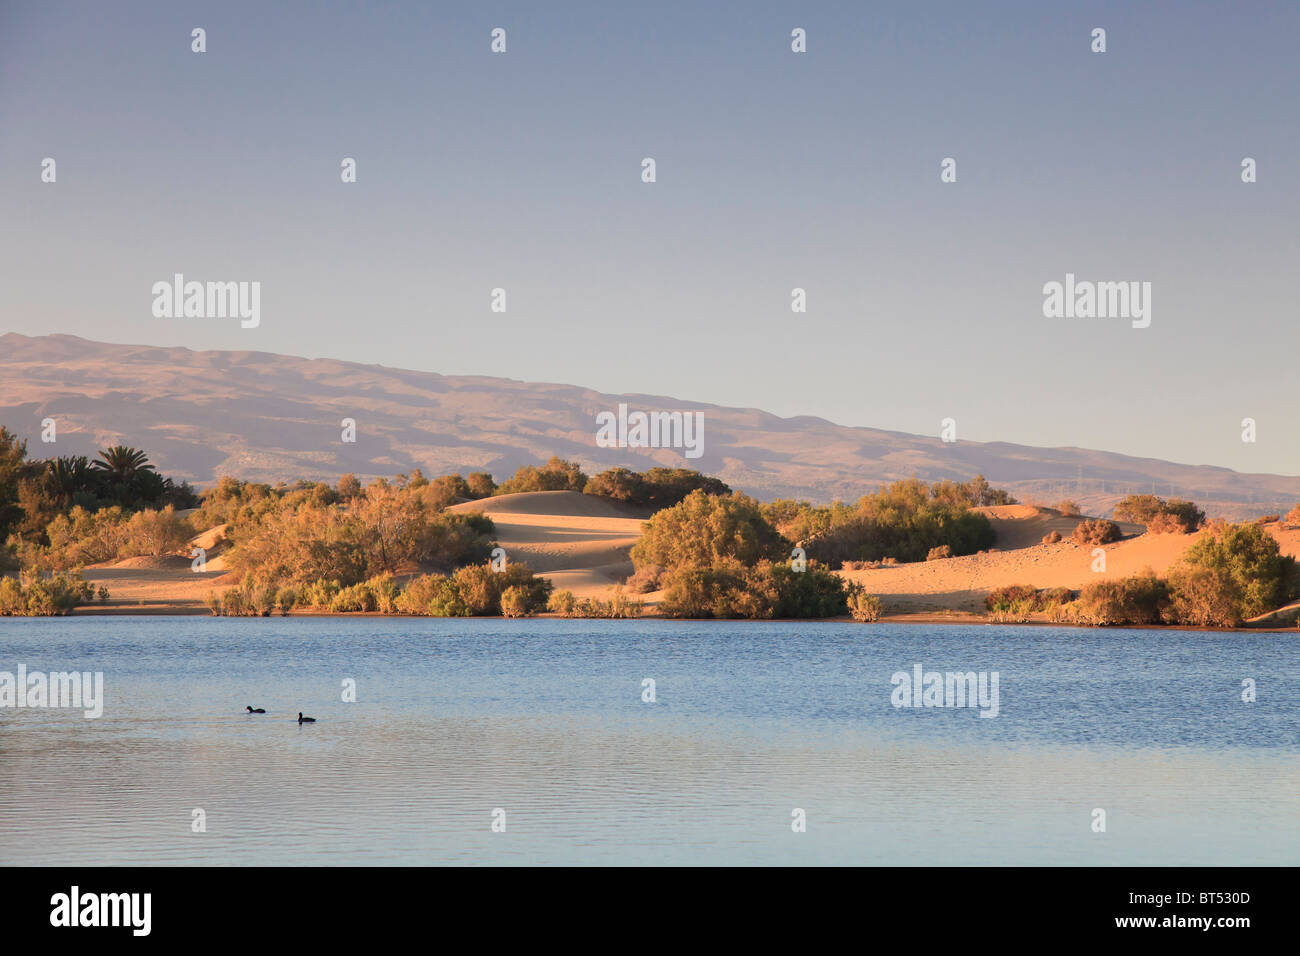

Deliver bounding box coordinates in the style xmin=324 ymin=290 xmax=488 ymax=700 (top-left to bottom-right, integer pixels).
xmin=0 ymin=333 xmax=1300 ymax=518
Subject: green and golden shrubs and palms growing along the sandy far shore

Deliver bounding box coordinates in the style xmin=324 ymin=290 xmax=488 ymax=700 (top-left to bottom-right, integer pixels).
xmin=0 ymin=428 xmax=1300 ymax=627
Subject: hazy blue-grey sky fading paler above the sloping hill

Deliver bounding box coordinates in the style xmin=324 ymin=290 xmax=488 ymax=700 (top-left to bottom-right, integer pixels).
xmin=0 ymin=0 xmax=1300 ymax=473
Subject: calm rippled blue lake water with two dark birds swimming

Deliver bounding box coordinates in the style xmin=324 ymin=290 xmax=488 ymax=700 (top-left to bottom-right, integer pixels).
xmin=0 ymin=618 xmax=1300 ymax=865
